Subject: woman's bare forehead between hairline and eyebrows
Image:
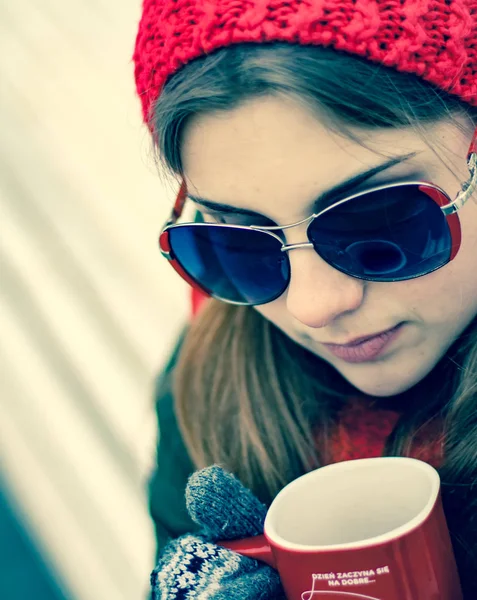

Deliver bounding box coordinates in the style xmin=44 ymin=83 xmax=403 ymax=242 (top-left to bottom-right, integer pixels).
xmin=182 ymin=97 xmax=440 ymax=219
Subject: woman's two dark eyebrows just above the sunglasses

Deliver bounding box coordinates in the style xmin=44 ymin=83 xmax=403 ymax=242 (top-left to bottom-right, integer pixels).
xmin=187 ymin=152 xmax=417 ymax=217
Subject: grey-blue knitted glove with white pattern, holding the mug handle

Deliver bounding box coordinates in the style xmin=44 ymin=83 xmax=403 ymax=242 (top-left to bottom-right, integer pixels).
xmin=151 ymin=466 xmax=285 ymax=600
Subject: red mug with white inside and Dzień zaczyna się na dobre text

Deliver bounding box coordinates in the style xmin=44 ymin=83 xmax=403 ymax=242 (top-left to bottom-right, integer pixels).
xmin=219 ymin=457 xmax=462 ymax=600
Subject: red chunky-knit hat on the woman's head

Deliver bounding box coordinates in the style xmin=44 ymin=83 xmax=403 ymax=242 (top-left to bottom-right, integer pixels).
xmin=133 ymin=0 xmax=477 ymax=121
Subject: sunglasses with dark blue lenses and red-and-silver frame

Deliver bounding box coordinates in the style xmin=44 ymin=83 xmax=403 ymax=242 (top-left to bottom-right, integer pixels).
xmin=159 ymin=129 xmax=477 ymax=306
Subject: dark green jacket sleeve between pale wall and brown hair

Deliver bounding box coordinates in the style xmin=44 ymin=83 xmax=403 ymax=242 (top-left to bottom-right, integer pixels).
xmin=149 ymin=333 xmax=196 ymax=554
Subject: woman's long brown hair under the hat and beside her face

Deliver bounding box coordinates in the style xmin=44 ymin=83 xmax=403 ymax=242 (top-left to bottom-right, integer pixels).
xmin=151 ymin=44 xmax=477 ymax=588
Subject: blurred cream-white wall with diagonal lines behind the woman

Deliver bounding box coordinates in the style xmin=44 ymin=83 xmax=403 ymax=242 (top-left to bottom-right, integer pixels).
xmin=0 ymin=0 xmax=188 ymax=600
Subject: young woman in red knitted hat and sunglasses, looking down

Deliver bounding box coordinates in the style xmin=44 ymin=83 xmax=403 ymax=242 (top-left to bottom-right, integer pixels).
xmin=134 ymin=0 xmax=477 ymax=600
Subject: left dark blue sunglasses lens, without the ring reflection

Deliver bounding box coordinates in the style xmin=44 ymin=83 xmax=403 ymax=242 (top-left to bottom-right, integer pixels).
xmin=169 ymin=224 xmax=290 ymax=304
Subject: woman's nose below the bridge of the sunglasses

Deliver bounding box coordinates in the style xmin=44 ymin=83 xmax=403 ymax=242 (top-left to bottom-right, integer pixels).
xmin=286 ymin=248 xmax=366 ymax=328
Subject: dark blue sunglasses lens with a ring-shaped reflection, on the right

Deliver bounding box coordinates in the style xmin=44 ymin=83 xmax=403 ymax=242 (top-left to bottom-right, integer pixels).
xmin=308 ymin=184 xmax=452 ymax=281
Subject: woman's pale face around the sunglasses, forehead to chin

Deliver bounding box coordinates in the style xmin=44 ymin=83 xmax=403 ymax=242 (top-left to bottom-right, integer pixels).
xmin=182 ymin=97 xmax=477 ymax=396
